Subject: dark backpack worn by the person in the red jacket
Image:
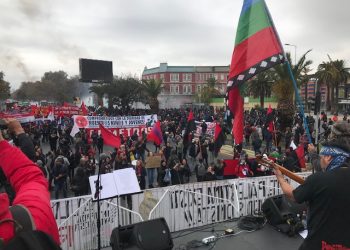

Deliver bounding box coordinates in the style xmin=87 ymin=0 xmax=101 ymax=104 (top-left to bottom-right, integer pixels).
xmin=0 ymin=205 xmax=61 ymax=250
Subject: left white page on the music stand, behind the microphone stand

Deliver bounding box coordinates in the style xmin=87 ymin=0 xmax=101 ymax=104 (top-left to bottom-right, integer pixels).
xmin=89 ymin=173 xmax=118 ymax=200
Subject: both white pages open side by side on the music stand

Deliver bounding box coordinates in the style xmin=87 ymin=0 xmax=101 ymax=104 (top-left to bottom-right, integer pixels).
xmin=89 ymin=168 xmax=141 ymax=201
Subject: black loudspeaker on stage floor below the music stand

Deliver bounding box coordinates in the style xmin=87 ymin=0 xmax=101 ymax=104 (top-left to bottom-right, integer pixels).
xmin=110 ymin=218 xmax=174 ymax=250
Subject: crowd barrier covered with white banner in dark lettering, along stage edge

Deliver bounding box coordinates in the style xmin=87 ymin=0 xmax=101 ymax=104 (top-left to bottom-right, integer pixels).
xmin=51 ymin=172 xmax=310 ymax=250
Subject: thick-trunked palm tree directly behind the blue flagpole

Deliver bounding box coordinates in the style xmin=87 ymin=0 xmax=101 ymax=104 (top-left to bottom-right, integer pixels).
xmin=272 ymin=50 xmax=312 ymax=128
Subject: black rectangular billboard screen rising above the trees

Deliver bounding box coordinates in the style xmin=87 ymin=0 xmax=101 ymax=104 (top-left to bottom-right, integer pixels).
xmin=79 ymin=58 xmax=113 ymax=83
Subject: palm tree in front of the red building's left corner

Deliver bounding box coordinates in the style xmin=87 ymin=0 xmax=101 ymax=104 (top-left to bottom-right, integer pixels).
xmin=142 ymin=79 xmax=163 ymax=112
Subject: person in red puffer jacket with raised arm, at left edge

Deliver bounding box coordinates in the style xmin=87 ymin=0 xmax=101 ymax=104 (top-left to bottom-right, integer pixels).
xmin=0 ymin=119 xmax=60 ymax=244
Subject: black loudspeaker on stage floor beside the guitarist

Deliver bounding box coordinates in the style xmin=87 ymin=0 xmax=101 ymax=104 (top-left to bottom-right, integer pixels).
xmin=261 ymin=195 xmax=306 ymax=226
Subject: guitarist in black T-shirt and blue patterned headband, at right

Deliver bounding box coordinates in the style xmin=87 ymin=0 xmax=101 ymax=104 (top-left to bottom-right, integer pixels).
xmin=275 ymin=122 xmax=350 ymax=250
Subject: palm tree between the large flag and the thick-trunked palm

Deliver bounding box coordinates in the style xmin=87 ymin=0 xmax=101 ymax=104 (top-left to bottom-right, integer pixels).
xmin=247 ymin=71 xmax=272 ymax=108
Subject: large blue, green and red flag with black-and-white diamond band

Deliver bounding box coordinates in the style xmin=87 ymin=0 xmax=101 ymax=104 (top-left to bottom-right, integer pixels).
xmin=226 ymin=0 xmax=284 ymax=145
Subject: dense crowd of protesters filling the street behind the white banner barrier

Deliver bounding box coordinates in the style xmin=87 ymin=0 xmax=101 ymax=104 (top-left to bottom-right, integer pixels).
xmin=3 ymin=105 xmax=346 ymax=199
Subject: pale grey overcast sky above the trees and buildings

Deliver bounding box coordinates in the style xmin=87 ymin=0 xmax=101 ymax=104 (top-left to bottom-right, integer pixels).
xmin=0 ymin=0 xmax=350 ymax=90
